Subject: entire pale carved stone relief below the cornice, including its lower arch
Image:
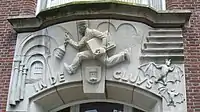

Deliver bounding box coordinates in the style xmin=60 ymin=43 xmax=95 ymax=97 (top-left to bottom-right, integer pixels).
xmin=7 ymin=19 xmax=186 ymax=112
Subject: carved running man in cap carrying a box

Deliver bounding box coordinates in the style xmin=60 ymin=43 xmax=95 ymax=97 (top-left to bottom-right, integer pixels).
xmin=64 ymin=21 xmax=129 ymax=74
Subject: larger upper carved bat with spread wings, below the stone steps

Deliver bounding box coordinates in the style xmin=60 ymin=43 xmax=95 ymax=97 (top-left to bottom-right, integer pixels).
xmin=138 ymin=59 xmax=183 ymax=86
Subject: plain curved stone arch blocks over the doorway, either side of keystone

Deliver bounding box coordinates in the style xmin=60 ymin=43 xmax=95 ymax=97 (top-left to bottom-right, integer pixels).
xmin=29 ymin=81 xmax=163 ymax=112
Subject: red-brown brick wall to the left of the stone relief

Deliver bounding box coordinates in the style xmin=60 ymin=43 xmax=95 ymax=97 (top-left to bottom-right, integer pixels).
xmin=0 ymin=0 xmax=36 ymax=112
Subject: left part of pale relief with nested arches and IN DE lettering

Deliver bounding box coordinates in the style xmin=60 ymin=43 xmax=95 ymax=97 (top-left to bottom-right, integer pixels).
xmin=7 ymin=22 xmax=81 ymax=111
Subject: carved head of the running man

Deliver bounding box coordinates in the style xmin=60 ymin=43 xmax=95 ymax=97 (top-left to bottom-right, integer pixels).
xmin=77 ymin=20 xmax=88 ymax=36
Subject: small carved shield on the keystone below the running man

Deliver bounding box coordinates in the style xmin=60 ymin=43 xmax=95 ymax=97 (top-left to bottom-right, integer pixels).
xmin=85 ymin=66 xmax=101 ymax=84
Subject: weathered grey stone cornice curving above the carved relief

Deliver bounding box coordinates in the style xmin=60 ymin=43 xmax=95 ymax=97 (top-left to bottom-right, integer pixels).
xmin=8 ymin=1 xmax=191 ymax=33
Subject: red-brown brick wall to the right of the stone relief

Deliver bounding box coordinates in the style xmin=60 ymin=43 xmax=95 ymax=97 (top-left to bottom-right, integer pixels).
xmin=166 ymin=0 xmax=200 ymax=112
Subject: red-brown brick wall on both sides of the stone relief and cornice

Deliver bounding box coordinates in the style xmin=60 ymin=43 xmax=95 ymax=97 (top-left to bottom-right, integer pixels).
xmin=0 ymin=0 xmax=197 ymax=112
